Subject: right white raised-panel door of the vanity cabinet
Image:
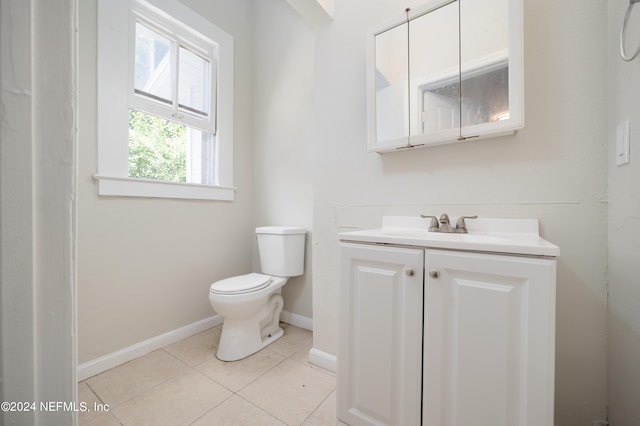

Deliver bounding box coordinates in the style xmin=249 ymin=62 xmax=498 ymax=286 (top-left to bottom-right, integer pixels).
xmin=423 ymin=250 xmax=556 ymax=426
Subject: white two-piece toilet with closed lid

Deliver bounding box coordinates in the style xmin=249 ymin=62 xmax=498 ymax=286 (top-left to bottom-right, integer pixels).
xmin=209 ymin=226 xmax=306 ymax=361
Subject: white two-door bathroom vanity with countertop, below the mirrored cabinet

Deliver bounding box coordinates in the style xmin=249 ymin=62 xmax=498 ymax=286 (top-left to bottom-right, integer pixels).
xmin=337 ymin=221 xmax=559 ymax=426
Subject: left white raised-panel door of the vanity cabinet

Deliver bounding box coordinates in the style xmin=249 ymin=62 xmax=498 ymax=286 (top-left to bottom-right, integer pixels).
xmin=337 ymin=243 xmax=424 ymax=426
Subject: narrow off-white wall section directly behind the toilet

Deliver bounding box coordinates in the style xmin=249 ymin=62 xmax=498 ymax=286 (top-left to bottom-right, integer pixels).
xmin=253 ymin=0 xmax=315 ymax=323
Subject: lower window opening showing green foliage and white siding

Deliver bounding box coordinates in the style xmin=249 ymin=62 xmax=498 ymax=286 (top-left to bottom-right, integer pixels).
xmin=129 ymin=109 xmax=215 ymax=184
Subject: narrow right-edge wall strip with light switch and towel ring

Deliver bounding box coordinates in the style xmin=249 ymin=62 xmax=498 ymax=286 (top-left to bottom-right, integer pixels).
xmin=607 ymin=0 xmax=640 ymax=426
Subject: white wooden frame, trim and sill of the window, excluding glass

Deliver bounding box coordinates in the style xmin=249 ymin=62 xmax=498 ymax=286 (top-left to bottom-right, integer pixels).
xmin=94 ymin=0 xmax=235 ymax=201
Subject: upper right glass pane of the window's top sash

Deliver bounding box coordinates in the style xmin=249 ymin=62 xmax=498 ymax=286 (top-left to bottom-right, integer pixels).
xmin=178 ymin=46 xmax=210 ymax=116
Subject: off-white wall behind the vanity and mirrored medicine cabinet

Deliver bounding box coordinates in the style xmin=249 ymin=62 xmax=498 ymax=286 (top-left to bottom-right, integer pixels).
xmin=313 ymin=0 xmax=608 ymax=426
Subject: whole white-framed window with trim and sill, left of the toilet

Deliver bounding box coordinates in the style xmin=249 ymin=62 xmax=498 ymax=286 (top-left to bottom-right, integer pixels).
xmin=96 ymin=0 xmax=234 ymax=200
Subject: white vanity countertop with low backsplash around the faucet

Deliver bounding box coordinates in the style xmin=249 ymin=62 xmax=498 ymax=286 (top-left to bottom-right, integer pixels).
xmin=338 ymin=216 xmax=560 ymax=257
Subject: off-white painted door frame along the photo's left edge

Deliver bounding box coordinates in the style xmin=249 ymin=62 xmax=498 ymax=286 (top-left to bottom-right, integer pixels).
xmin=0 ymin=0 xmax=76 ymax=425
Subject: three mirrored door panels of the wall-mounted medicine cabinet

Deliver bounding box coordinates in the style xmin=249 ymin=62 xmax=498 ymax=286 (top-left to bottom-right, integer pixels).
xmin=375 ymin=0 xmax=510 ymax=145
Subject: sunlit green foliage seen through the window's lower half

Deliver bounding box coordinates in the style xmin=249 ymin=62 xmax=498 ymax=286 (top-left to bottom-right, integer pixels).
xmin=129 ymin=110 xmax=187 ymax=182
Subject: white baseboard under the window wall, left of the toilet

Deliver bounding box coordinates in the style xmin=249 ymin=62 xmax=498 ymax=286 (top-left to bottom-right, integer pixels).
xmin=77 ymin=315 xmax=224 ymax=381
